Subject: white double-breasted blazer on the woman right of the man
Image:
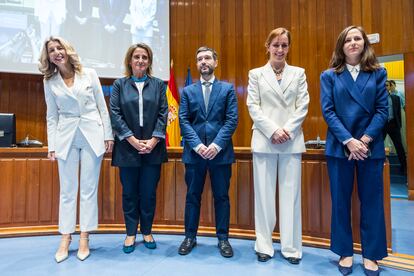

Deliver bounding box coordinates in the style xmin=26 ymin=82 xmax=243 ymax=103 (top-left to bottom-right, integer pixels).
xmin=246 ymin=63 xmax=309 ymax=153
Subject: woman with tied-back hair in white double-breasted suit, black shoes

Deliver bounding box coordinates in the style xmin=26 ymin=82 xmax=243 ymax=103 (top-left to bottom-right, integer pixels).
xmin=247 ymin=28 xmax=309 ymax=264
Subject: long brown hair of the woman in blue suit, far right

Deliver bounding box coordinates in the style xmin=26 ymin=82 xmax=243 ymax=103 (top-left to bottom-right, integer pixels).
xmin=329 ymin=25 xmax=380 ymax=73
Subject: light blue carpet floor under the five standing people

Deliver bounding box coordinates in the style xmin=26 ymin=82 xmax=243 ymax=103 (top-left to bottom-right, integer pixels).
xmin=0 ymin=234 xmax=412 ymax=276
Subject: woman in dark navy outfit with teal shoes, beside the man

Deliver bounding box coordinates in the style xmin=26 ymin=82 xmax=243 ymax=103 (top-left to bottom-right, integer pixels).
xmin=110 ymin=43 xmax=168 ymax=253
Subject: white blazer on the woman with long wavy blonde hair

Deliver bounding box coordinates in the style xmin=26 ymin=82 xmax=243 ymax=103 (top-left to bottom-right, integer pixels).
xmin=43 ymin=68 xmax=113 ymax=160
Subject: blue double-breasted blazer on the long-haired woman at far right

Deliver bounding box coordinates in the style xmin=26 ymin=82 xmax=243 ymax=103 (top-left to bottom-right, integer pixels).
xmin=320 ymin=68 xmax=388 ymax=158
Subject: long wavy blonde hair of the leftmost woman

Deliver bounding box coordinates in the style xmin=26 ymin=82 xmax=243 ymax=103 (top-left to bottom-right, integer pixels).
xmin=38 ymin=36 xmax=82 ymax=80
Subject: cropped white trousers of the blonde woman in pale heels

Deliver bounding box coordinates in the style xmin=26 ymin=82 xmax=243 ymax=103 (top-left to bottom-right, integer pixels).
xmin=57 ymin=128 xmax=103 ymax=234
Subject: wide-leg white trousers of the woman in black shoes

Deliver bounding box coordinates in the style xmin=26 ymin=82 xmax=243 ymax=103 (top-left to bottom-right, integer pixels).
xmin=253 ymin=152 xmax=302 ymax=258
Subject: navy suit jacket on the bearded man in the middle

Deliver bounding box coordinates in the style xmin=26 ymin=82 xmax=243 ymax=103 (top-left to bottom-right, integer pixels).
xmin=179 ymin=79 xmax=238 ymax=164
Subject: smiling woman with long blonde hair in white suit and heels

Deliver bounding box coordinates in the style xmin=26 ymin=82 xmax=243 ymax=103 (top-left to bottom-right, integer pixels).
xmin=39 ymin=37 xmax=113 ymax=262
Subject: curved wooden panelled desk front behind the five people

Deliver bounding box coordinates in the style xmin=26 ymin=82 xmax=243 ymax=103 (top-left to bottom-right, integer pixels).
xmin=0 ymin=148 xmax=391 ymax=250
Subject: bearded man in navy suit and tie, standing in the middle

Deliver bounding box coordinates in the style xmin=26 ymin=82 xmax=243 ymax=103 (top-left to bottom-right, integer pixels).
xmin=178 ymin=46 xmax=238 ymax=258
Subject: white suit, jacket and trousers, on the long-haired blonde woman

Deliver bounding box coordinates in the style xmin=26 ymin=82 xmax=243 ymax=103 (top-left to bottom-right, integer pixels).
xmin=43 ymin=68 xmax=114 ymax=234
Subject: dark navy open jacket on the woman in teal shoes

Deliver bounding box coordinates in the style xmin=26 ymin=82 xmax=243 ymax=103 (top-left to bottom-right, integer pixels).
xmin=110 ymin=77 xmax=168 ymax=167
